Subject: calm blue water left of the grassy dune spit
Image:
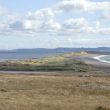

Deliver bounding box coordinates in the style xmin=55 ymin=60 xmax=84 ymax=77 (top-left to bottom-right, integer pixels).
xmin=0 ymin=52 xmax=61 ymax=61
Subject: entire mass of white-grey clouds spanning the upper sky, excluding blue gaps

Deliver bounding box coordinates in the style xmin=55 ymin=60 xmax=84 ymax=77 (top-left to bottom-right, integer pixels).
xmin=0 ymin=0 xmax=110 ymax=36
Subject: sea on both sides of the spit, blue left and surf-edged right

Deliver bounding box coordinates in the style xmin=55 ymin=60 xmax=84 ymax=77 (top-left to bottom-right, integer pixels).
xmin=0 ymin=52 xmax=110 ymax=63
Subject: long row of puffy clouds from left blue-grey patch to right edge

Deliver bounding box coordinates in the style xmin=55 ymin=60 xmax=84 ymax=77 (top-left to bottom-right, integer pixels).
xmin=6 ymin=13 xmax=110 ymax=35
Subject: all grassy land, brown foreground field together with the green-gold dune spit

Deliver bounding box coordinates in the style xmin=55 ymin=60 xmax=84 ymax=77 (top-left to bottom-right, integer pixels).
xmin=0 ymin=52 xmax=110 ymax=110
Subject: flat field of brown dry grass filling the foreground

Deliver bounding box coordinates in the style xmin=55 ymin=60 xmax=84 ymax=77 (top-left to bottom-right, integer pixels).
xmin=0 ymin=74 xmax=110 ymax=110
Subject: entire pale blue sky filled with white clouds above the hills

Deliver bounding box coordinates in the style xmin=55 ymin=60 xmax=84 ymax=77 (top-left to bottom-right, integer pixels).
xmin=0 ymin=0 xmax=110 ymax=50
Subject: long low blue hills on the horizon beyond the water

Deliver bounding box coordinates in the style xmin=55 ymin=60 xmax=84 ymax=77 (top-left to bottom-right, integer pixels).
xmin=0 ymin=47 xmax=110 ymax=53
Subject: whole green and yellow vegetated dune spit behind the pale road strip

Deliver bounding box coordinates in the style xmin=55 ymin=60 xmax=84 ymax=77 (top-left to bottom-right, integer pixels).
xmin=0 ymin=52 xmax=94 ymax=72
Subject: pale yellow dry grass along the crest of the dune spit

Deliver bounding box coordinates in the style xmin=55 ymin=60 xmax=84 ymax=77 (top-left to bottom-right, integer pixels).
xmin=8 ymin=52 xmax=88 ymax=65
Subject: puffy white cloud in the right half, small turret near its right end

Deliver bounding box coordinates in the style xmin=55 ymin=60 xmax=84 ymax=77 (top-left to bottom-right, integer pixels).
xmin=60 ymin=18 xmax=110 ymax=35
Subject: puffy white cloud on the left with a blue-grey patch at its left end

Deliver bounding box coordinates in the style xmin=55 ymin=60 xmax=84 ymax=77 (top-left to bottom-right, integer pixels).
xmin=9 ymin=14 xmax=61 ymax=33
